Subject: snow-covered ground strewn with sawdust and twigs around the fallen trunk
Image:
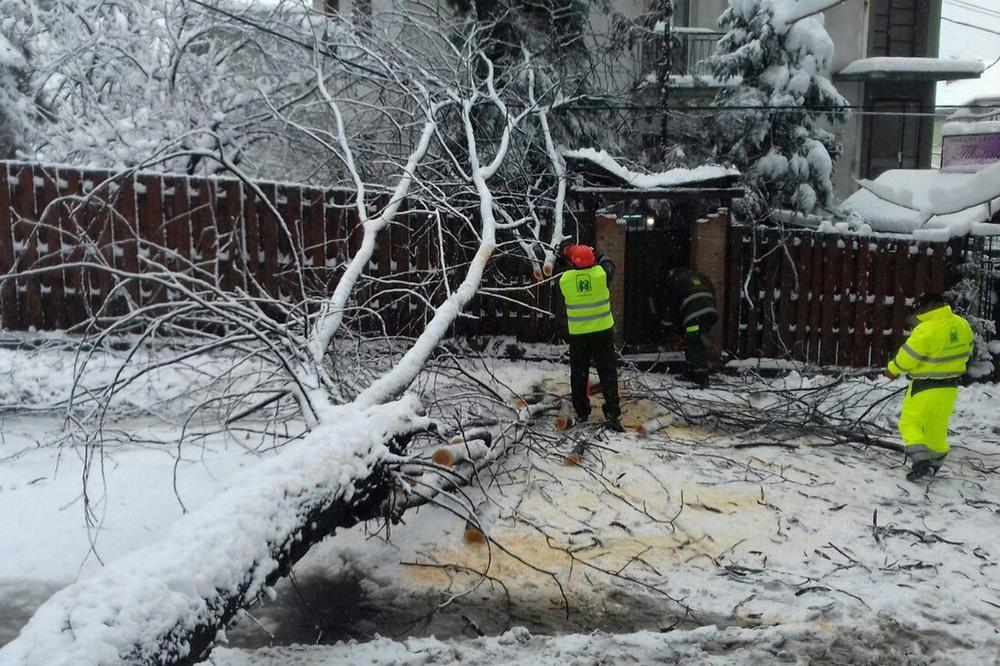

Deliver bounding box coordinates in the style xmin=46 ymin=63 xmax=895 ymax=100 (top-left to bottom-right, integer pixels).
xmin=0 ymin=350 xmax=1000 ymax=666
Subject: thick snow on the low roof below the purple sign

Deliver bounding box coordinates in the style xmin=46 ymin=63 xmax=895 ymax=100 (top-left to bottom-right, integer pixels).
xmin=840 ymin=164 xmax=1000 ymax=241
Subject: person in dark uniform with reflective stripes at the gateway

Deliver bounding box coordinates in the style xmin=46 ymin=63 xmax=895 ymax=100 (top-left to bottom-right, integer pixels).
xmin=657 ymin=268 xmax=719 ymax=386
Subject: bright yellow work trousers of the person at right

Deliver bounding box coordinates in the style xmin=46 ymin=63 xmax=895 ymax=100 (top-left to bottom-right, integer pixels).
xmin=899 ymin=382 xmax=958 ymax=467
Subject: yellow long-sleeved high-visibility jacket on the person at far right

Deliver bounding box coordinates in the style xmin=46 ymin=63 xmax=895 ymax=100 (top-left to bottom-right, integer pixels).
xmin=889 ymin=305 xmax=975 ymax=379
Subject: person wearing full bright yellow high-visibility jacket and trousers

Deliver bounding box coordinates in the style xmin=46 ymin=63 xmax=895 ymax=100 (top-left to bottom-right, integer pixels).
xmin=885 ymin=293 xmax=974 ymax=481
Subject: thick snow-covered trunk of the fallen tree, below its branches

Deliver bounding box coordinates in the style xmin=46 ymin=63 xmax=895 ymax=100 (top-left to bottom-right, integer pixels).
xmin=0 ymin=399 xmax=426 ymax=666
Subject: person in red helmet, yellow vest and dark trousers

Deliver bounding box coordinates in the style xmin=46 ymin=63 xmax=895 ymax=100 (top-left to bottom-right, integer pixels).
xmin=559 ymin=245 xmax=623 ymax=432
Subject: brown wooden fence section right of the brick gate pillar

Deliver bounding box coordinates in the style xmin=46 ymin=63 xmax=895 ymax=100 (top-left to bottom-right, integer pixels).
xmin=724 ymin=227 xmax=965 ymax=367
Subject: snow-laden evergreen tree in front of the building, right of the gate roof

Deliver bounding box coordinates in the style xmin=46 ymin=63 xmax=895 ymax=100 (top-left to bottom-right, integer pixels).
xmin=710 ymin=0 xmax=847 ymax=217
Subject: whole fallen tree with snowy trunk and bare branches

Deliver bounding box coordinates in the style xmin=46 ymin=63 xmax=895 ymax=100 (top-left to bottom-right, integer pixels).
xmin=0 ymin=2 xmax=584 ymax=666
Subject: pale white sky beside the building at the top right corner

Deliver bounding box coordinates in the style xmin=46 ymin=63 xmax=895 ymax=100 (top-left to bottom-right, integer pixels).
xmin=937 ymin=0 xmax=1000 ymax=105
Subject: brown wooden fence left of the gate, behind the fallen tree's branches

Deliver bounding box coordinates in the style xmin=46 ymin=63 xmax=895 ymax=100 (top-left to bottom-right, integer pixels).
xmin=0 ymin=162 xmax=556 ymax=341
